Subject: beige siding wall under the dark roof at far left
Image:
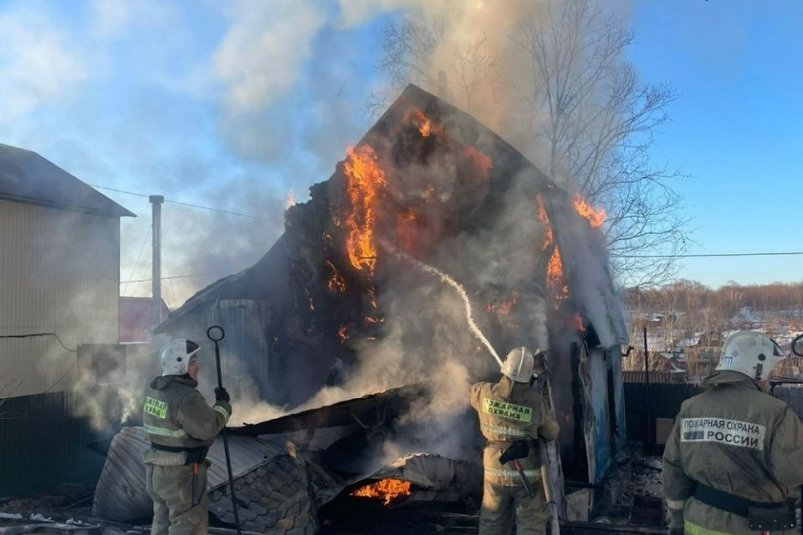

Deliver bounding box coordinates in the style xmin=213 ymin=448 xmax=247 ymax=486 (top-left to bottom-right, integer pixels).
xmin=0 ymin=200 xmax=120 ymax=399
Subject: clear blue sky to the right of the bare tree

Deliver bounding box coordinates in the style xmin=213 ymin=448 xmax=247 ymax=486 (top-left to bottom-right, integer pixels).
xmin=629 ymin=0 xmax=803 ymax=286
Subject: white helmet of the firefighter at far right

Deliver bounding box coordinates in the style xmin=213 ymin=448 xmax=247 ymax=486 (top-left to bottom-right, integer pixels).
xmin=716 ymin=331 xmax=786 ymax=381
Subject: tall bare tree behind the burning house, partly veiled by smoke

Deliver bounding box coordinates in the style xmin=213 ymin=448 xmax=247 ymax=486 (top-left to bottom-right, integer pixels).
xmin=370 ymin=0 xmax=687 ymax=286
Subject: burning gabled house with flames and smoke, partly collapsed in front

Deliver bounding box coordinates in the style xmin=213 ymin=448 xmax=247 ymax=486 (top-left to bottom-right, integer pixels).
xmin=94 ymin=86 xmax=627 ymax=527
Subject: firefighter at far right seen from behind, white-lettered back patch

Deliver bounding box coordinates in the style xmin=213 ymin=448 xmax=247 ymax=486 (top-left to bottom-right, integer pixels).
xmin=662 ymin=331 xmax=803 ymax=535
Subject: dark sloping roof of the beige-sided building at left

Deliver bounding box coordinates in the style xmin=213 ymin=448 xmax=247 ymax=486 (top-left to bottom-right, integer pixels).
xmin=0 ymin=143 xmax=134 ymax=217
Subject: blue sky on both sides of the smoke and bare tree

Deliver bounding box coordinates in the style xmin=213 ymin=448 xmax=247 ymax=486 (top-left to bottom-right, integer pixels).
xmin=0 ymin=0 xmax=803 ymax=306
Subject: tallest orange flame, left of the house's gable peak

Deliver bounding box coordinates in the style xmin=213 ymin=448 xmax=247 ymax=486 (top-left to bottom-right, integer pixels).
xmin=344 ymin=144 xmax=386 ymax=275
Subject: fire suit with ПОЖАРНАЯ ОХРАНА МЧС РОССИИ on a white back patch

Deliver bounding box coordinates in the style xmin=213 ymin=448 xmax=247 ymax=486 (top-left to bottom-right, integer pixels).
xmin=662 ymin=371 xmax=803 ymax=535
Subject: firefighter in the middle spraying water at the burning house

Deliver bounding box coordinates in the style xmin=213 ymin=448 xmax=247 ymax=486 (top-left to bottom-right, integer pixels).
xmin=471 ymin=347 xmax=558 ymax=535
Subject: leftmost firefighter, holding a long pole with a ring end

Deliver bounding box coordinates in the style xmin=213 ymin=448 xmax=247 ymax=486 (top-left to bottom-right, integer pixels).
xmin=143 ymin=339 xmax=231 ymax=535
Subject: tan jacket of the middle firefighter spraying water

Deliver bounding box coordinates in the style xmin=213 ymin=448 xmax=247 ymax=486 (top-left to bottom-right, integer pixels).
xmin=471 ymin=376 xmax=558 ymax=486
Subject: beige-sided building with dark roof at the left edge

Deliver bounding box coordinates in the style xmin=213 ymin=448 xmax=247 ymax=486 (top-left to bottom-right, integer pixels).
xmin=0 ymin=144 xmax=134 ymax=398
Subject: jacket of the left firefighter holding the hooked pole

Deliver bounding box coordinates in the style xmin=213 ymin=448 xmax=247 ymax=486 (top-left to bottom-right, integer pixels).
xmin=142 ymin=375 xmax=231 ymax=464
